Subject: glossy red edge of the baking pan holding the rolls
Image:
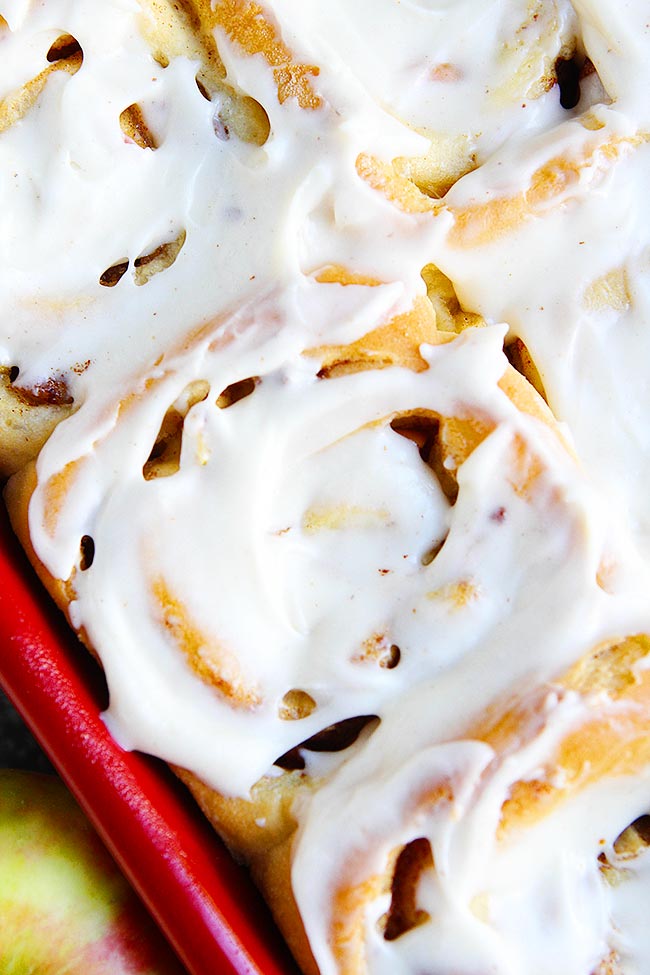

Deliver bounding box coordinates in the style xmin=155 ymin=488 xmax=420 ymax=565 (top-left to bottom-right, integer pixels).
xmin=0 ymin=506 xmax=298 ymax=975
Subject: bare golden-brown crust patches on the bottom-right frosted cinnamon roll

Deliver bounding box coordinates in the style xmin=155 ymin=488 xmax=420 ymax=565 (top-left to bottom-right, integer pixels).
xmin=330 ymin=634 xmax=650 ymax=975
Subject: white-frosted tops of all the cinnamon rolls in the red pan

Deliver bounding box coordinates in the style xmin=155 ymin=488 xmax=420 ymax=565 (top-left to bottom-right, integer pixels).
xmin=0 ymin=0 xmax=650 ymax=975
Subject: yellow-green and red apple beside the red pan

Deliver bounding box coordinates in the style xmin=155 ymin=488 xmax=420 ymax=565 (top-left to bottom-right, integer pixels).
xmin=0 ymin=769 xmax=184 ymax=975
